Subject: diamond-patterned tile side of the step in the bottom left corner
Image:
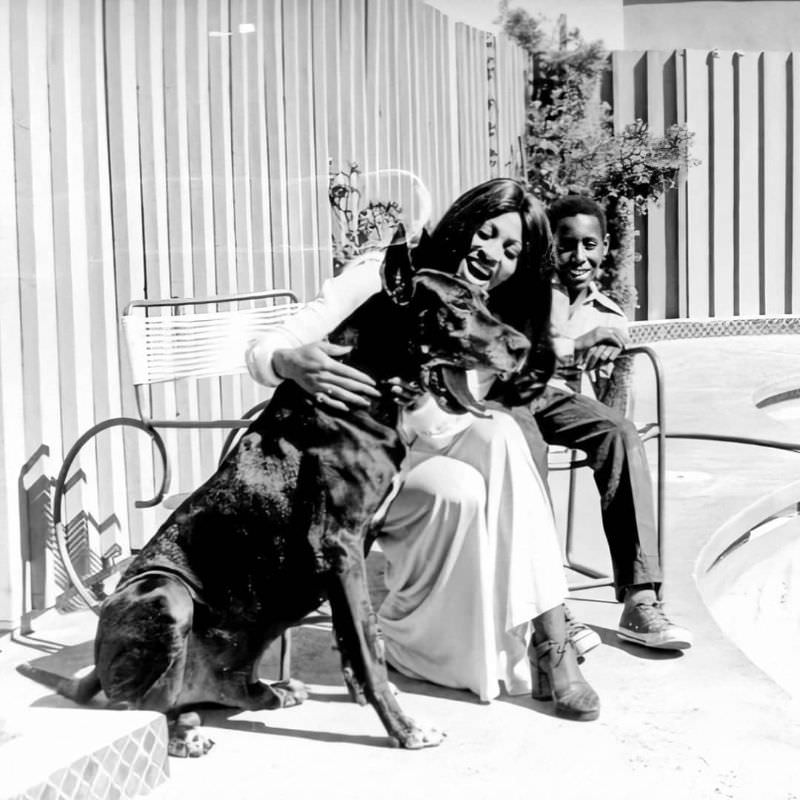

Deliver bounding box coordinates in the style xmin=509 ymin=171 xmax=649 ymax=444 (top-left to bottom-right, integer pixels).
xmin=4 ymin=715 xmax=169 ymax=800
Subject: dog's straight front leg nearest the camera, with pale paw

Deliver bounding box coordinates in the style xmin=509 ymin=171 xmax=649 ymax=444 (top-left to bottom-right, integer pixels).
xmin=328 ymin=553 xmax=444 ymax=750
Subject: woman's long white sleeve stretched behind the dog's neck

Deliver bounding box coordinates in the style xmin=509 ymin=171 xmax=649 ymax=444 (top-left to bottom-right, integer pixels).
xmin=245 ymin=252 xmax=383 ymax=387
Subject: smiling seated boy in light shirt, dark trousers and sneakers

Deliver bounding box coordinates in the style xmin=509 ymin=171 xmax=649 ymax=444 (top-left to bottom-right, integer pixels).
xmin=534 ymin=196 xmax=692 ymax=650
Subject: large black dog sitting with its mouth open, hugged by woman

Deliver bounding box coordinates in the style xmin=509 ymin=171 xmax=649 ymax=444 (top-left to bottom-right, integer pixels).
xmin=19 ymin=233 xmax=529 ymax=755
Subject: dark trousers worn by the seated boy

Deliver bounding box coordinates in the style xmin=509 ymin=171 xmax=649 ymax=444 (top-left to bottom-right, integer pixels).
xmin=532 ymin=387 xmax=661 ymax=600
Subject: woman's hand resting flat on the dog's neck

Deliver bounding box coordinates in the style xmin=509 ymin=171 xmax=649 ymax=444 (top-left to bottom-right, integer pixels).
xmin=272 ymin=342 xmax=381 ymax=411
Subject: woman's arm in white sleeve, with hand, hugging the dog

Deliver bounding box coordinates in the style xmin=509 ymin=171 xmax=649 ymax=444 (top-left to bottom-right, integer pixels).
xmin=246 ymin=253 xmax=383 ymax=410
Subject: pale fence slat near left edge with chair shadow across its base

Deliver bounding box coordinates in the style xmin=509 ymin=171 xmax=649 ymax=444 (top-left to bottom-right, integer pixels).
xmin=10 ymin=0 xmax=61 ymax=608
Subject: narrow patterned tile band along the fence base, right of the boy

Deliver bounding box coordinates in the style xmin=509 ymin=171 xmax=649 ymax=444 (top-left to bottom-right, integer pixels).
xmin=630 ymin=314 xmax=800 ymax=344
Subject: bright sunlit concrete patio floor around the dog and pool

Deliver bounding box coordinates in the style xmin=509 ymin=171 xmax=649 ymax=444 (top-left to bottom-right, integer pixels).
xmin=0 ymin=336 xmax=800 ymax=800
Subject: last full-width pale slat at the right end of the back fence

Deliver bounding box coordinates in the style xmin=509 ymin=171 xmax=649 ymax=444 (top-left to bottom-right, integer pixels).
xmin=760 ymin=52 xmax=786 ymax=314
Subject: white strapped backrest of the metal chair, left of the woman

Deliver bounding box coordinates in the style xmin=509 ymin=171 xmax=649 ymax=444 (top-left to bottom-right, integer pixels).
xmin=122 ymin=289 xmax=301 ymax=419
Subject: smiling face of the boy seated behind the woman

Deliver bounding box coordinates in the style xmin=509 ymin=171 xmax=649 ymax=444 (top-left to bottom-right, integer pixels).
xmin=553 ymin=214 xmax=608 ymax=301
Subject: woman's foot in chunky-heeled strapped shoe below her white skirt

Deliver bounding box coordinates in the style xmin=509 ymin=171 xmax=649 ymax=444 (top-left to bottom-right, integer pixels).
xmin=528 ymin=605 xmax=600 ymax=721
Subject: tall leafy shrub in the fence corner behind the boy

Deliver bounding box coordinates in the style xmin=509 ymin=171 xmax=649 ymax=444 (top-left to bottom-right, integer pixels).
xmin=498 ymin=0 xmax=697 ymax=314
